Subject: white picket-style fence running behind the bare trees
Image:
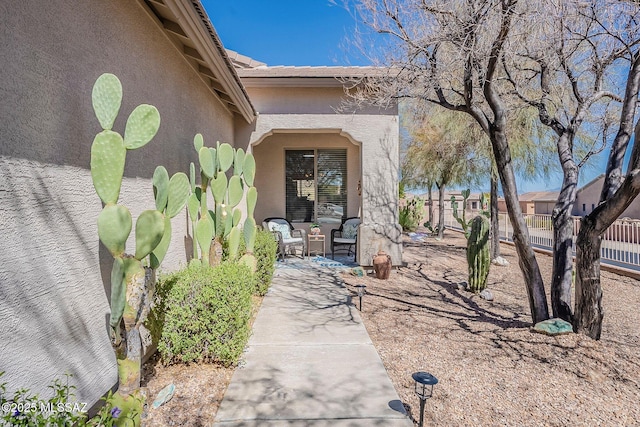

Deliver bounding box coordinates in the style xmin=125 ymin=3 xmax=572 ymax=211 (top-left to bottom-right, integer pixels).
xmin=442 ymin=209 xmax=640 ymax=270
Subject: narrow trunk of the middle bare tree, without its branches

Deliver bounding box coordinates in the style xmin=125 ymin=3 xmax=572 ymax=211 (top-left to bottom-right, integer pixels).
xmin=551 ymin=133 xmax=578 ymax=323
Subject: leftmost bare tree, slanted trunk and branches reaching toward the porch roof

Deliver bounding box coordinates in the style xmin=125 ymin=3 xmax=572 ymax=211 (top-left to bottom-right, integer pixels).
xmin=354 ymin=0 xmax=549 ymax=323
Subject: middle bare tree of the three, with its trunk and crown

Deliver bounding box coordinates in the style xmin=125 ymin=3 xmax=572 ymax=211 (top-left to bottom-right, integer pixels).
xmin=502 ymin=0 xmax=625 ymax=322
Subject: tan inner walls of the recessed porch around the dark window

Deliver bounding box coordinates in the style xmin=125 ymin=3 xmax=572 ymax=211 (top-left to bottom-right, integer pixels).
xmin=253 ymin=133 xmax=361 ymax=251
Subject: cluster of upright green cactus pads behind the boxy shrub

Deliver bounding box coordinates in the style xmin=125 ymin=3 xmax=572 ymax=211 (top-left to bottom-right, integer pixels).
xmin=188 ymin=134 xmax=258 ymax=269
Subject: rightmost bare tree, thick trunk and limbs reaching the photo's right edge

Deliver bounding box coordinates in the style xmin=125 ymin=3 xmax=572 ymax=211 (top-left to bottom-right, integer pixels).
xmin=574 ymin=1 xmax=640 ymax=339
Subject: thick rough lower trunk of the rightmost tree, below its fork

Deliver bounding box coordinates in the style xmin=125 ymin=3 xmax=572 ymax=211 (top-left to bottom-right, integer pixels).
xmin=573 ymin=216 xmax=604 ymax=340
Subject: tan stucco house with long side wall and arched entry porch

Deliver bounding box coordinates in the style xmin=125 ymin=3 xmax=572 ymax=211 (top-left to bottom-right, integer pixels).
xmin=0 ymin=0 xmax=401 ymax=412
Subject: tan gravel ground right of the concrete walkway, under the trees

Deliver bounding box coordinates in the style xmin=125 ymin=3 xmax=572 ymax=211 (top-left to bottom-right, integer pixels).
xmin=343 ymin=232 xmax=640 ymax=426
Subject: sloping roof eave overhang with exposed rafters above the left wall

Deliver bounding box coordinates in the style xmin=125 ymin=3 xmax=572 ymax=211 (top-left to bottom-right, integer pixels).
xmin=138 ymin=0 xmax=256 ymax=123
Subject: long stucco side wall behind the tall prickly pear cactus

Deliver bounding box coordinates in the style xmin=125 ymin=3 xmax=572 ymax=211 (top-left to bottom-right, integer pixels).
xmin=0 ymin=0 xmax=234 ymax=403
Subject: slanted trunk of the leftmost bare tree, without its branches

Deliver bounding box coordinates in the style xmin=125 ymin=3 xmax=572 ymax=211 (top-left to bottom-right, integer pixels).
xmin=490 ymin=132 xmax=549 ymax=323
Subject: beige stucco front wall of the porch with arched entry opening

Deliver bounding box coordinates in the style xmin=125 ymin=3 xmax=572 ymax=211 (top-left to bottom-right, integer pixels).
xmin=237 ymin=85 xmax=402 ymax=266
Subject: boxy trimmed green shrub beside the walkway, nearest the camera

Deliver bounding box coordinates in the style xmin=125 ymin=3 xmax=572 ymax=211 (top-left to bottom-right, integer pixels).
xmin=156 ymin=261 xmax=255 ymax=366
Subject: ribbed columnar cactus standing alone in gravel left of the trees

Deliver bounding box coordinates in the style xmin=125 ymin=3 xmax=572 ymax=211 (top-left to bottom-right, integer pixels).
xmin=467 ymin=215 xmax=491 ymax=293
